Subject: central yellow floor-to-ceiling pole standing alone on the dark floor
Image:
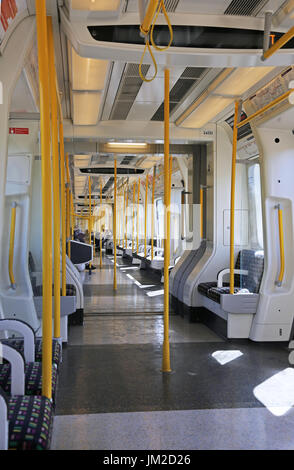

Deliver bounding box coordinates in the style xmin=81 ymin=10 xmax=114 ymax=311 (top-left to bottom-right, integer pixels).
xmin=162 ymin=69 xmax=171 ymax=372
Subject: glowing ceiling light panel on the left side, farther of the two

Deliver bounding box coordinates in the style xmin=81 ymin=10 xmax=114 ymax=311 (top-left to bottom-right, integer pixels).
xmin=73 ymin=92 xmax=101 ymax=126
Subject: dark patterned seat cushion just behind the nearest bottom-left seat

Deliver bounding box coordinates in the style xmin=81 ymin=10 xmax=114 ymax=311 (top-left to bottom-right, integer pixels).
xmin=0 ymin=362 xmax=58 ymax=402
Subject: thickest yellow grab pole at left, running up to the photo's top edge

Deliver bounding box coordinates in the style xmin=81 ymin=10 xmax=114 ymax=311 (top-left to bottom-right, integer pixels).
xmin=36 ymin=0 xmax=52 ymax=399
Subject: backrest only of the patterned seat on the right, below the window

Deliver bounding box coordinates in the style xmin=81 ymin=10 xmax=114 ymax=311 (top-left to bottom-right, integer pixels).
xmin=235 ymin=250 xmax=264 ymax=294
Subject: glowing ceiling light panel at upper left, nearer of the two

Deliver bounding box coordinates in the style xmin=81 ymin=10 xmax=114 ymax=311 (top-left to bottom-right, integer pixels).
xmin=71 ymin=47 xmax=109 ymax=91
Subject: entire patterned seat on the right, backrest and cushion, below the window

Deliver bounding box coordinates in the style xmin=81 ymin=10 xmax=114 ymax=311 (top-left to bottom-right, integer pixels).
xmin=198 ymin=250 xmax=264 ymax=303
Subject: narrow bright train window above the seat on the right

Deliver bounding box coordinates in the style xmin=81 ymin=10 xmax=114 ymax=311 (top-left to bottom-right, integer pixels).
xmin=248 ymin=163 xmax=263 ymax=249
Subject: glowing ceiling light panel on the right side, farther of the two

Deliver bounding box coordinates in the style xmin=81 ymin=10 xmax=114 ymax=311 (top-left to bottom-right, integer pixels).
xmin=182 ymin=95 xmax=234 ymax=129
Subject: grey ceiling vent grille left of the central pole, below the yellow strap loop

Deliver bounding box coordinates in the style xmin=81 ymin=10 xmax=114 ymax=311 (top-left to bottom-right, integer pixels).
xmin=109 ymin=64 xmax=150 ymax=120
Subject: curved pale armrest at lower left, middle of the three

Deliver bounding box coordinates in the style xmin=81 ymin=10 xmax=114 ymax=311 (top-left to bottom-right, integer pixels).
xmin=0 ymin=344 xmax=25 ymax=396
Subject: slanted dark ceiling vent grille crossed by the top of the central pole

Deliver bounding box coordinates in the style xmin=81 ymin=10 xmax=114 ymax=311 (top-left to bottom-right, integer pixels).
xmin=151 ymin=67 xmax=208 ymax=121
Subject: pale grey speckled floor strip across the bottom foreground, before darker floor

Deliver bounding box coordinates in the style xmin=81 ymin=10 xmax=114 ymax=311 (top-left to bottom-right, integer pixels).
xmin=52 ymin=408 xmax=294 ymax=450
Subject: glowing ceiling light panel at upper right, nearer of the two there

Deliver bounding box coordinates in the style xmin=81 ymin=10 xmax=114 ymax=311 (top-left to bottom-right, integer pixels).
xmin=216 ymin=67 xmax=274 ymax=96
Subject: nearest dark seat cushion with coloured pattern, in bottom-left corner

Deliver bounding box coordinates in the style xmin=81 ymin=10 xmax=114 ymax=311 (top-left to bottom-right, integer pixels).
xmin=8 ymin=396 xmax=53 ymax=450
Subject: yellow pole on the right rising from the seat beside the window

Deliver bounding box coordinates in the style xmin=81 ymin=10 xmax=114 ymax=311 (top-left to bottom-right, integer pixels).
xmin=230 ymin=101 xmax=239 ymax=294
